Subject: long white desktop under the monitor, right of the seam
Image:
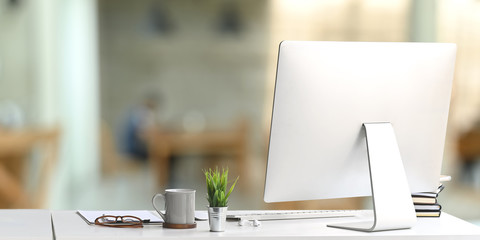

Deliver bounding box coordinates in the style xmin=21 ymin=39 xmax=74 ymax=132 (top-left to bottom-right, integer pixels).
xmin=52 ymin=211 xmax=480 ymax=240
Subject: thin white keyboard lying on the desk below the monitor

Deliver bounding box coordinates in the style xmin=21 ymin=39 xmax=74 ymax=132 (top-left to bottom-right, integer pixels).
xmin=227 ymin=210 xmax=368 ymax=220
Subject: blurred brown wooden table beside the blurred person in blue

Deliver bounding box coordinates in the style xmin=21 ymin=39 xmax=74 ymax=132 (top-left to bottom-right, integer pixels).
xmin=147 ymin=120 xmax=248 ymax=187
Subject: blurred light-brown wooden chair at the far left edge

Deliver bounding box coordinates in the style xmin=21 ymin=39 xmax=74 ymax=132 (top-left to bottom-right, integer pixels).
xmin=0 ymin=128 xmax=60 ymax=208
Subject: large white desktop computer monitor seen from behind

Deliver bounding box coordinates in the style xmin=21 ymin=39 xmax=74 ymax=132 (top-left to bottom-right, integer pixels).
xmin=264 ymin=41 xmax=456 ymax=231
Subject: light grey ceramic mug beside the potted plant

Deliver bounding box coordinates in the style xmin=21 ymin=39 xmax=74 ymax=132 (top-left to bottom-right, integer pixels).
xmin=152 ymin=189 xmax=195 ymax=224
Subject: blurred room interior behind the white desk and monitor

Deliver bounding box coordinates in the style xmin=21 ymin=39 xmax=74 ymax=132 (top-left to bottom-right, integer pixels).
xmin=0 ymin=0 xmax=480 ymax=224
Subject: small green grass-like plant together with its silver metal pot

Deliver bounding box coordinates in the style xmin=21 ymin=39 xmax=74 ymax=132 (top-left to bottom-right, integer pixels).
xmin=203 ymin=167 xmax=238 ymax=232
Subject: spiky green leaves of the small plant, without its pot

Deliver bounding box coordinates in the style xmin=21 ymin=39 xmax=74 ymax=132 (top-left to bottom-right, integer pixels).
xmin=203 ymin=167 xmax=238 ymax=207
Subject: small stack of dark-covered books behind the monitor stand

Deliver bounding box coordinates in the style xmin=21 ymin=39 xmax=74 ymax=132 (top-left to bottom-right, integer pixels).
xmin=412 ymin=184 xmax=445 ymax=217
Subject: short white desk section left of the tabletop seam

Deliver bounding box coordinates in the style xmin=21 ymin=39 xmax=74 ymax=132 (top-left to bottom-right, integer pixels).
xmin=0 ymin=209 xmax=53 ymax=240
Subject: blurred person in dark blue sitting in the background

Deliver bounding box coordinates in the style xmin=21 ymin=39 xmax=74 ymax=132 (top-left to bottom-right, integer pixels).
xmin=121 ymin=94 xmax=159 ymax=161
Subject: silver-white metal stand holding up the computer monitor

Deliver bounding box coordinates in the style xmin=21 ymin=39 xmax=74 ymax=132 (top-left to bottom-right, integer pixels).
xmin=327 ymin=122 xmax=417 ymax=232
